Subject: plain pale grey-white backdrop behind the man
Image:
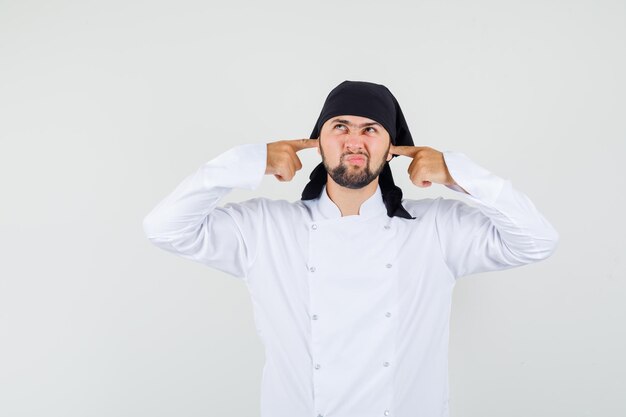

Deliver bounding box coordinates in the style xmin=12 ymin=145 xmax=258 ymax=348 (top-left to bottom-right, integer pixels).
xmin=0 ymin=0 xmax=626 ymax=417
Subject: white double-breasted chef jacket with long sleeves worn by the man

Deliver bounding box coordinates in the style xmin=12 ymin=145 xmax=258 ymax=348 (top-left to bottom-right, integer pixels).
xmin=143 ymin=143 xmax=558 ymax=417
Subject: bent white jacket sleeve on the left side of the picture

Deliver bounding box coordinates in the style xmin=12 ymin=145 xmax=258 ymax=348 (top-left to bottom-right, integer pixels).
xmin=143 ymin=143 xmax=267 ymax=279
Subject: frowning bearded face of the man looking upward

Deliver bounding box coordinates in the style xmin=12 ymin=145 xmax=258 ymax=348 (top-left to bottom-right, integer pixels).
xmin=318 ymin=115 xmax=392 ymax=189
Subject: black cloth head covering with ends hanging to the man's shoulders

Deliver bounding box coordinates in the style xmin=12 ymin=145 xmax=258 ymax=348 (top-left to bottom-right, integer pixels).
xmin=302 ymin=80 xmax=415 ymax=219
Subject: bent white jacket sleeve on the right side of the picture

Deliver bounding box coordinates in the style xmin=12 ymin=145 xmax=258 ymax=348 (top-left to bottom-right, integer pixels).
xmin=436 ymin=151 xmax=559 ymax=278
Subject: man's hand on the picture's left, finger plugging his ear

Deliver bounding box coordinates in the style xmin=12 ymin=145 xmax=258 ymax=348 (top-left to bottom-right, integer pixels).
xmin=265 ymin=139 xmax=319 ymax=181
